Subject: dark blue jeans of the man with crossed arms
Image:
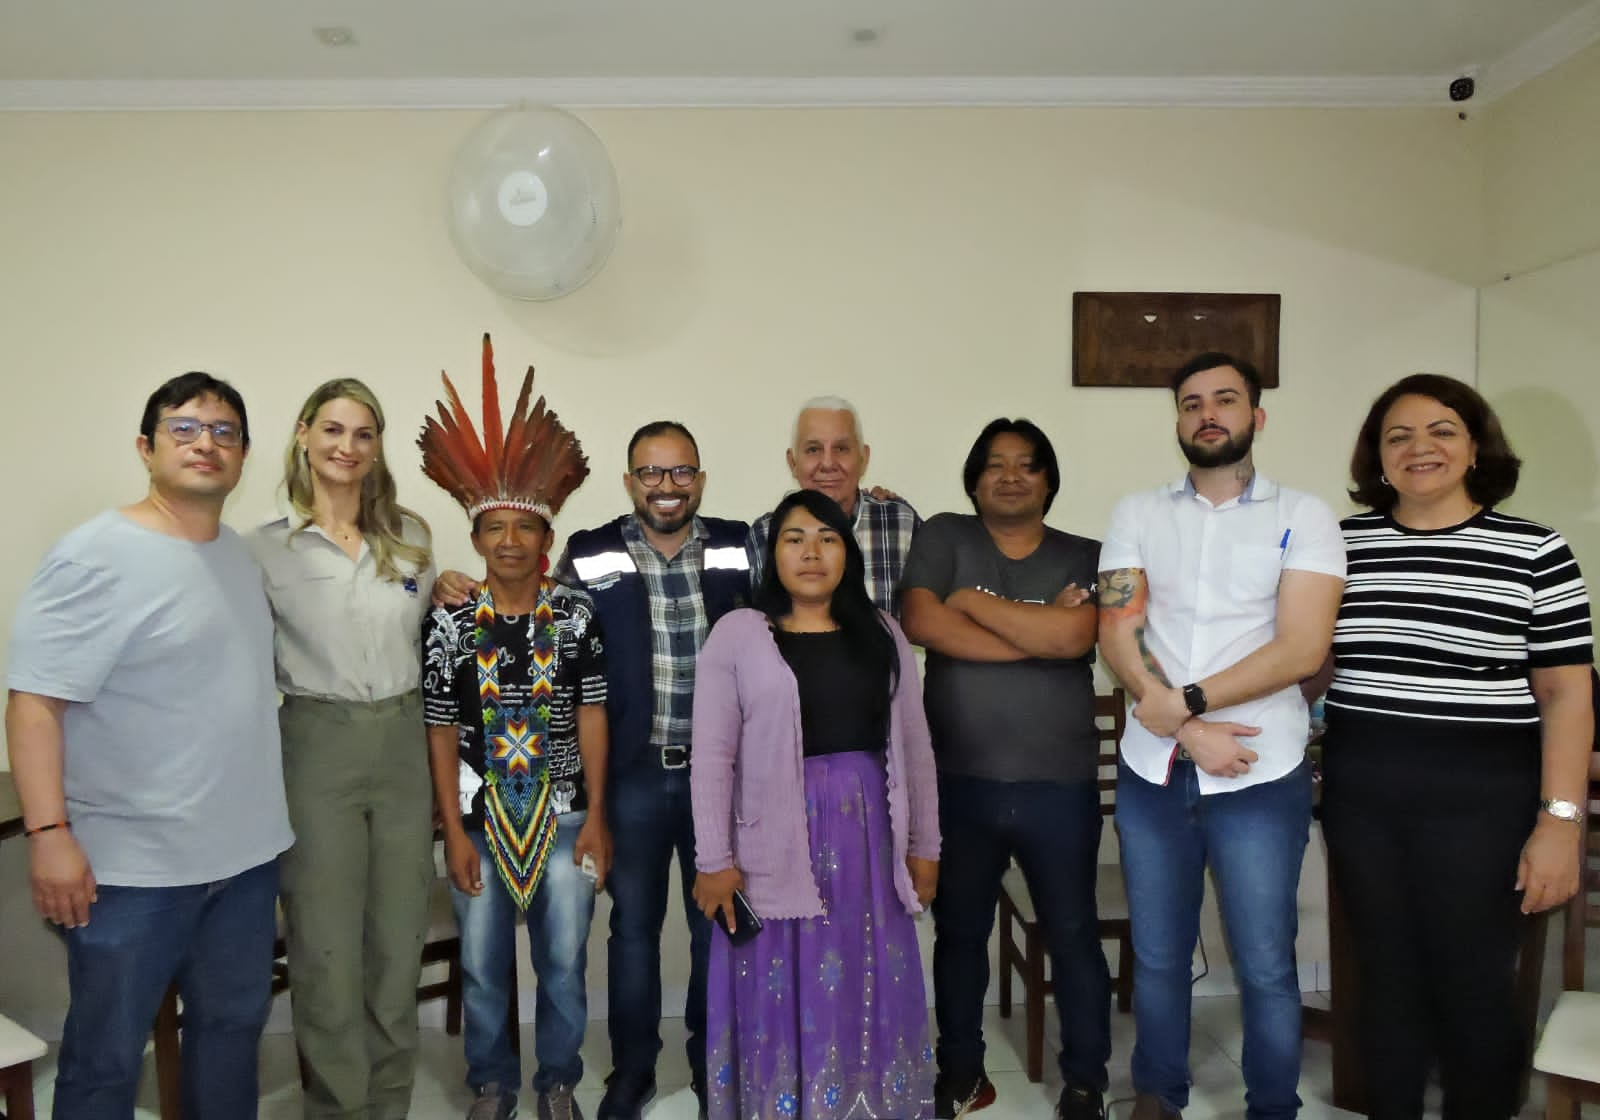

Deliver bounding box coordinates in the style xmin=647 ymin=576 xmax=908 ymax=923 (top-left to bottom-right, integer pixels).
xmin=933 ymin=774 xmax=1110 ymax=1091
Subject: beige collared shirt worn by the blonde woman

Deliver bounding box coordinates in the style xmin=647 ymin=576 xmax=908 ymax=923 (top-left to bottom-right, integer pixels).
xmin=246 ymin=517 xmax=437 ymax=702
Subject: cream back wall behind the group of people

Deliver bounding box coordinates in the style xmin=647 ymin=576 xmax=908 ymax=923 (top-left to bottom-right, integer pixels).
xmin=0 ymin=110 xmax=1483 ymax=1032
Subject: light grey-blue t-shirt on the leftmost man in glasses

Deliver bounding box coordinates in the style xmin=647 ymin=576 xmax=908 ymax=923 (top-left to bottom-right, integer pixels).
xmin=6 ymin=512 xmax=294 ymax=886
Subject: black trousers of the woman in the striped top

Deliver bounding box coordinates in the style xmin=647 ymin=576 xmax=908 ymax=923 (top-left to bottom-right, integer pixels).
xmin=1322 ymin=730 xmax=1542 ymax=1120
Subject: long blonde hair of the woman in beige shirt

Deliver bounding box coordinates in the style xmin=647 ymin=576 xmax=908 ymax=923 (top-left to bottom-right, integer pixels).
xmin=283 ymin=378 xmax=432 ymax=581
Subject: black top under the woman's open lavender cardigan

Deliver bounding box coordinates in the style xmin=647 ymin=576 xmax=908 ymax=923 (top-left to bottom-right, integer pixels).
xmin=773 ymin=630 xmax=890 ymax=758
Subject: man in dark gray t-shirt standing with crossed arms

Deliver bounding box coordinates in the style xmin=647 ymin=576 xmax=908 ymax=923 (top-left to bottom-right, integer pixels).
xmin=901 ymin=419 xmax=1110 ymax=1120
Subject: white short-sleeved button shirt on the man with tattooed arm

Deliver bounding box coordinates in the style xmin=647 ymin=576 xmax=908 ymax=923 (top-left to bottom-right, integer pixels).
xmin=1099 ymin=472 xmax=1344 ymax=794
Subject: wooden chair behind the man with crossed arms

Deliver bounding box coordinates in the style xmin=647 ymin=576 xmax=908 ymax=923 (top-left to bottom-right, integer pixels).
xmin=1000 ymin=688 xmax=1133 ymax=1082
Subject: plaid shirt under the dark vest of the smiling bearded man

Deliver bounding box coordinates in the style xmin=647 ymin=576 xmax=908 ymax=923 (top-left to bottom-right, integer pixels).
xmin=622 ymin=517 xmax=710 ymax=747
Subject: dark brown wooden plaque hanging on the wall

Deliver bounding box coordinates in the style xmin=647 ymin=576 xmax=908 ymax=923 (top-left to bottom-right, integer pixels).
xmin=1072 ymin=291 xmax=1283 ymax=389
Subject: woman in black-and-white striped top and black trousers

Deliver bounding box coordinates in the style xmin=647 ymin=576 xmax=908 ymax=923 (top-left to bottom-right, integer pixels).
xmin=1323 ymin=374 xmax=1594 ymax=1120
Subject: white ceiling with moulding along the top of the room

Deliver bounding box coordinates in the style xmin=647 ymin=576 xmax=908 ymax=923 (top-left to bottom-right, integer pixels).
xmin=0 ymin=0 xmax=1600 ymax=107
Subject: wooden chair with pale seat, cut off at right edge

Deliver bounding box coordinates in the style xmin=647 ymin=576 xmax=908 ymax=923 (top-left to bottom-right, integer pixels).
xmin=1533 ymin=781 xmax=1600 ymax=1120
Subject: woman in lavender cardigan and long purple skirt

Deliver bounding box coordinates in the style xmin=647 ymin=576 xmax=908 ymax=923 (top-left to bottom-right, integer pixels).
xmin=690 ymin=490 xmax=939 ymax=1120
